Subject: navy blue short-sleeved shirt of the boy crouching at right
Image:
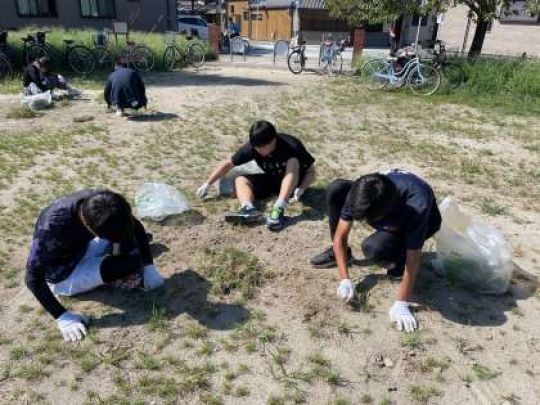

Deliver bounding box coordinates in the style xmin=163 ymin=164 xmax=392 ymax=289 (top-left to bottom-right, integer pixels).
xmin=341 ymin=169 xmax=441 ymax=250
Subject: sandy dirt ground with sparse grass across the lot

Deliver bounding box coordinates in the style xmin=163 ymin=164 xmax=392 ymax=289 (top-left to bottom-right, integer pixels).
xmin=0 ymin=63 xmax=540 ymax=405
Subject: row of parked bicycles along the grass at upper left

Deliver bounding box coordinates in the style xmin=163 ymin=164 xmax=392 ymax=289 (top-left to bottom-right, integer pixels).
xmin=0 ymin=31 xmax=205 ymax=80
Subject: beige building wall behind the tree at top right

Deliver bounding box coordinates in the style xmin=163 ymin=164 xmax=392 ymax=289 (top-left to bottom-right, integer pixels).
xmin=438 ymin=1 xmax=540 ymax=57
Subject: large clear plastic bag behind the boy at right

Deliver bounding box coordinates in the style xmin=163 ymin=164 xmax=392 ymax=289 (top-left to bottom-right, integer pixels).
xmin=433 ymin=197 xmax=513 ymax=294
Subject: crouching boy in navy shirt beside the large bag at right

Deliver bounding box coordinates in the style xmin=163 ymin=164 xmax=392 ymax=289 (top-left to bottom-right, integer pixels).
xmin=311 ymin=170 xmax=441 ymax=332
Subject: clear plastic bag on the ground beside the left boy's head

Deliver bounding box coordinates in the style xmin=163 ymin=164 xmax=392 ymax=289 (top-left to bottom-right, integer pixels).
xmin=135 ymin=182 xmax=191 ymax=221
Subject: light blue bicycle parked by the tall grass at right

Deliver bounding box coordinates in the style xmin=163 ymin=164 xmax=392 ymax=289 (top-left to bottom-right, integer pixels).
xmin=360 ymin=52 xmax=441 ymax=96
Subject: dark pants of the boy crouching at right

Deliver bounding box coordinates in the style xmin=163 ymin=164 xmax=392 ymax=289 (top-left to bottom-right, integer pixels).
xmin=326 ymin=179 xmax=437 ymax=270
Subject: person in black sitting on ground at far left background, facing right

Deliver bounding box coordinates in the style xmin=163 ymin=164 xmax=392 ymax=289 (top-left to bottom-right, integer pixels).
xmin=23 ymin=56 xmax=81 ymax=96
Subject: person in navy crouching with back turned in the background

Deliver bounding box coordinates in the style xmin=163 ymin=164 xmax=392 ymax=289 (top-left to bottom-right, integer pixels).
xmin=104 ymin=60 xmax=148 ymax=117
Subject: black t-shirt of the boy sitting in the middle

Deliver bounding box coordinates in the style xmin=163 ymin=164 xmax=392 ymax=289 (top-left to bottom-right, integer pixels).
xmin=232 ymin=134 xmax=315 ymax=179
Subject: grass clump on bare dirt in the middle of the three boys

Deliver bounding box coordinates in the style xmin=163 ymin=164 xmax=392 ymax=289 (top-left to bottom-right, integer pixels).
xmin=200 ymin=247 xmax=263 ymax=299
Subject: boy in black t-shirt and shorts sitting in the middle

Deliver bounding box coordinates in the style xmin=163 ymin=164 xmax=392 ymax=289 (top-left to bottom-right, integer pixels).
xmin=197 ymin=121 xmax=315 ymax=231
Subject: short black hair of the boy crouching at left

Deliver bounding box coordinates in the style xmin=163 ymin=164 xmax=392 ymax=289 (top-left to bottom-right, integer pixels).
xmin=81 ymin=190 xmax=133 ymax=242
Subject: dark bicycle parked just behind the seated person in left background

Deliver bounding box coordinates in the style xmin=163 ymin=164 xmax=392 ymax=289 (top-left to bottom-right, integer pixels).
xmin=21 ymin=31 xmax=96 ymax=75
